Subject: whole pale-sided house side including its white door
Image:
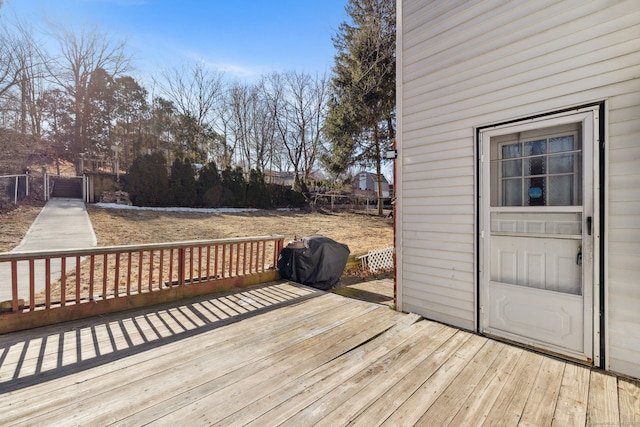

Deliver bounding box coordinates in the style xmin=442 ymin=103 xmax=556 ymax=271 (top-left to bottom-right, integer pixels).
xmin=396 ymin=0 xmax=640 ymax=378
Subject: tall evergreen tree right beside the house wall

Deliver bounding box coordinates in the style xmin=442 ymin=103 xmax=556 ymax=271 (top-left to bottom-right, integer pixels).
xmin=323 ymin=0 xmax=396 ymax=215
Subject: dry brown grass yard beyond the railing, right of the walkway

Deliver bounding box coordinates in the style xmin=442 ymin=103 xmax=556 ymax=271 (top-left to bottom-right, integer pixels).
xmin=87 ymin=205 xmax=393 ymax=254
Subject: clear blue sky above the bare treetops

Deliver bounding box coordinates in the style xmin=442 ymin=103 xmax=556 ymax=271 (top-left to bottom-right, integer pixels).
xmin=0 ymin=0 xmax=348 ymax=81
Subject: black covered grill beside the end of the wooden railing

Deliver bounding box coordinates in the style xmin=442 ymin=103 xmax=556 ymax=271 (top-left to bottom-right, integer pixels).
xmin=278 ymin=235 xmax=349 ymax=290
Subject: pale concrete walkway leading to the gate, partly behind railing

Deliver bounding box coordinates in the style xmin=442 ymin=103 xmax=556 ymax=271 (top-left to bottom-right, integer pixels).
xmin=0 ymin=198 xmax=97 ymax=301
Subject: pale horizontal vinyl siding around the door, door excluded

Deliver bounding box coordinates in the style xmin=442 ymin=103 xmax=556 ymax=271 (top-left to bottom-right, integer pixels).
xmin=396 ymin=0 xmax=640 ymax=377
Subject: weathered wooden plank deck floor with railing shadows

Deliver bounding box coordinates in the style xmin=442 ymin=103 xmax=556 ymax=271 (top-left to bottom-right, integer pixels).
xmin=0 ymin=282 xmax=640 ymax=427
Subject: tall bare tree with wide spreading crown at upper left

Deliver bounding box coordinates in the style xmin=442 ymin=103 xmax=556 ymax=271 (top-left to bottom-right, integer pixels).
xmin=47 ymin=26 xmax=130 ymax=161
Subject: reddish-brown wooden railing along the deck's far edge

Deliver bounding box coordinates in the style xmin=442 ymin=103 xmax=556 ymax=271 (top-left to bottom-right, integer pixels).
xmin=0 ymin=235 xmax=284 ymax=333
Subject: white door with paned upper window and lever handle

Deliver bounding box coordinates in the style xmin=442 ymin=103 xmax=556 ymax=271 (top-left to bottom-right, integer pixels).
xmin=479 ymin=110 xmax=597 ymax=363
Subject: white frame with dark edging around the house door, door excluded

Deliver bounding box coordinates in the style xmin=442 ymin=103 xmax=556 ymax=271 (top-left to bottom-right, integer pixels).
xmin=474 ymin=101 xmax=605 ymax=367
